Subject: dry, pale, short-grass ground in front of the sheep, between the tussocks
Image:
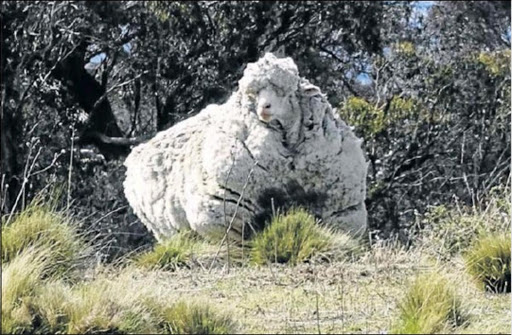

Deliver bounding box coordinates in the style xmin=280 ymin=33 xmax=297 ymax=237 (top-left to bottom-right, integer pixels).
xmin=111 ymin=245 xmax=511 ymax=334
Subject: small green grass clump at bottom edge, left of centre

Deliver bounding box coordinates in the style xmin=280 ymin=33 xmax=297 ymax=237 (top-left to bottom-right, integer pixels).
xmin=155 ymin=302 xmax=236 ymax=334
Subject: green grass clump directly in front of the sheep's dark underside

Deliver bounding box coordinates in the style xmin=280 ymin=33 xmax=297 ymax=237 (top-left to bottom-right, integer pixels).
xmin=251 ymin=208 xmax=333 ymax=265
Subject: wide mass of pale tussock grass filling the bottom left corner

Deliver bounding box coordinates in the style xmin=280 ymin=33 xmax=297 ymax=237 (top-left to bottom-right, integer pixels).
xmin=2 ymin=267 xmax=237 ymax=334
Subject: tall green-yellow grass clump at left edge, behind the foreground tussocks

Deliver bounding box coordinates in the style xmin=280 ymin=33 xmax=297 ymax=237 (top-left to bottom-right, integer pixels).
xmin=2 ymin=201 xmax=85 ymax=275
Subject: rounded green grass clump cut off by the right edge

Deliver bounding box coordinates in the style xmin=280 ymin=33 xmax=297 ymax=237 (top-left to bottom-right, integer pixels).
xmin=466 ymin=233 xmax=511 ymax=293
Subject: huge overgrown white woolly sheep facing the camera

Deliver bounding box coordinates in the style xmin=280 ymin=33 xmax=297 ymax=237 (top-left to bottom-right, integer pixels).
xmin=124 ymin=54 xmax=368 ymax=240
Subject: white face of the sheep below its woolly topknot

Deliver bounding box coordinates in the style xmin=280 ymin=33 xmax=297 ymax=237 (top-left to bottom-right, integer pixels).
xmin=256 ymin=87 xmax=293 ymax=125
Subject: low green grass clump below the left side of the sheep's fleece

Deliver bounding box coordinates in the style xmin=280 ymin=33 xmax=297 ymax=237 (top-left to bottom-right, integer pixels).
xmin=134 ymin=231 xmax=206 ymax=270
